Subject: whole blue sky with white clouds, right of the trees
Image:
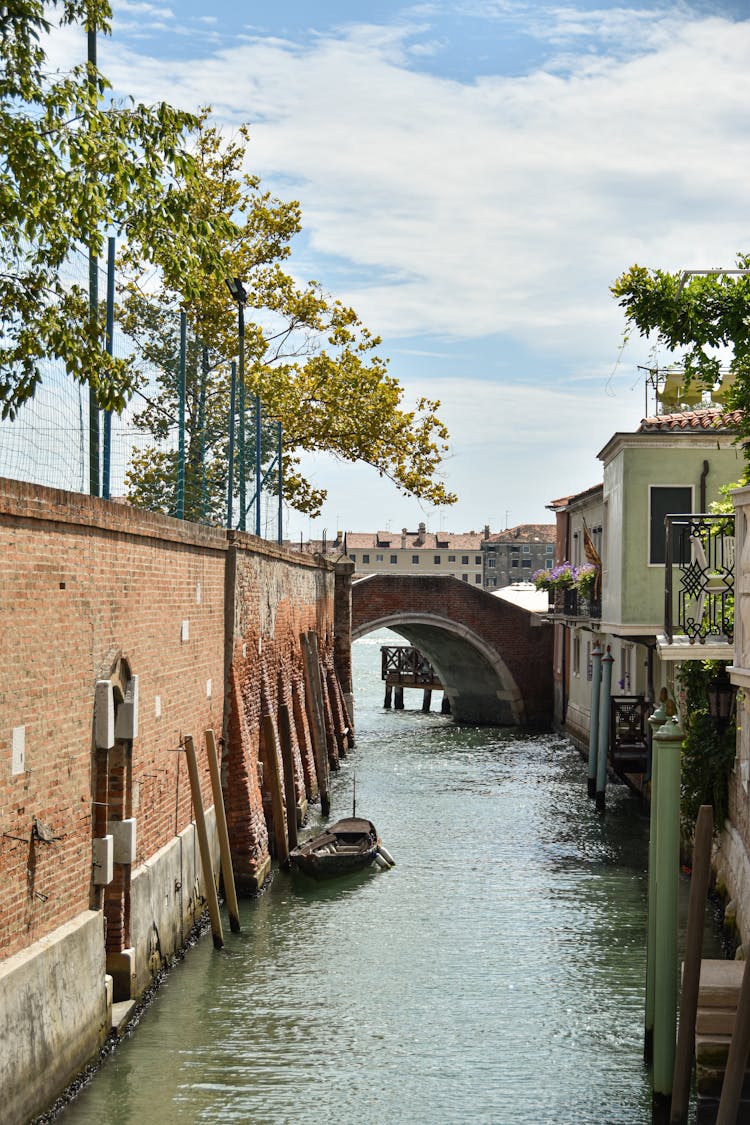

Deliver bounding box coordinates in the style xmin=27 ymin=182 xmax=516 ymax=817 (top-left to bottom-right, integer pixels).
xmin=54 ymin=0 xmax=750 ymax=539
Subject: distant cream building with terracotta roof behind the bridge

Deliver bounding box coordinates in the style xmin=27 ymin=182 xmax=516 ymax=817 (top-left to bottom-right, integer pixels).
xmin=343 ymin=523 xmax=489 ymax=586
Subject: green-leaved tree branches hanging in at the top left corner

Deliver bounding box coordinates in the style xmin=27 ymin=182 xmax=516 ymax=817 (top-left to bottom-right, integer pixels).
xmin=0 ymin=0 xmax=229 ymax=419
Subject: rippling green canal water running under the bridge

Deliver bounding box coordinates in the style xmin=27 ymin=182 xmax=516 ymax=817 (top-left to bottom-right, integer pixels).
xmin=60 ymin=631 xmax=720 ymax=1125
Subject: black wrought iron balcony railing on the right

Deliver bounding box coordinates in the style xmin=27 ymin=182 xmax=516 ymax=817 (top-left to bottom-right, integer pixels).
xmin=665 ymin=513 xmax=734 ymax=645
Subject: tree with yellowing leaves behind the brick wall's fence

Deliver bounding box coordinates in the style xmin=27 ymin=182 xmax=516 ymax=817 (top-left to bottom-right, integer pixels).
xmin=118 ymin=111 xmax=455 ymax=514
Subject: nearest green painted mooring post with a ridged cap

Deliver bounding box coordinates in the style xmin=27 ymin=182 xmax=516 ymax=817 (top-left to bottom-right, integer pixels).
xmin=652 ymin=718 xmax=683 ymax=1107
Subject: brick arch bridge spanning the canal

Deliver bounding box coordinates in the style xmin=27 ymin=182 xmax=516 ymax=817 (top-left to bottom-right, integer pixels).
xmin=352 ymin=575 xmax=553 ymax=728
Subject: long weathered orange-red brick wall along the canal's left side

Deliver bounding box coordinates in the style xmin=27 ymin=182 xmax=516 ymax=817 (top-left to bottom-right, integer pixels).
xmin=0 ymin=480 xmax=346 ymax=956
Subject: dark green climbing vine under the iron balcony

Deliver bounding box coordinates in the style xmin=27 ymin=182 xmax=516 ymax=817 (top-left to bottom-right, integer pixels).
xmin=678 ymin=660 xmax=737 ymax=837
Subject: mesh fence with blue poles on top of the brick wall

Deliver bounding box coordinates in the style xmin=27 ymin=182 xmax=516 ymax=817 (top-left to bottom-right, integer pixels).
xmin=0 ymin=245 xmax=283 ymax=541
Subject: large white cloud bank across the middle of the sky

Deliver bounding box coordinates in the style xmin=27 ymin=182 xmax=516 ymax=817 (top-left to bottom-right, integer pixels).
xmin=96 ymin=11 xmax=750 ymax=364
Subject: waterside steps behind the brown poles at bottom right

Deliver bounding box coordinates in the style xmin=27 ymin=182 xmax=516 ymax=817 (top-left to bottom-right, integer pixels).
xmin=695 ymin=960 xmax=750 ymax=1125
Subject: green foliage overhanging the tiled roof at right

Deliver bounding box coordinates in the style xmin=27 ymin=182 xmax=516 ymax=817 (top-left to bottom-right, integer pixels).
xmin=612 ymin=254 xmax=750 ymax=482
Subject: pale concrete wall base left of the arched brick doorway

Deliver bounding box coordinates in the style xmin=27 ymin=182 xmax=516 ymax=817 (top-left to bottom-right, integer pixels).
xmin=0 ymin=910 xmax=111 ymax=1125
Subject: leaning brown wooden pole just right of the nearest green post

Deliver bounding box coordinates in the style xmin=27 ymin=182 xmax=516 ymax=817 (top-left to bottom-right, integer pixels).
xmin=669 ymin=804 xmax=714 ymax=1125
